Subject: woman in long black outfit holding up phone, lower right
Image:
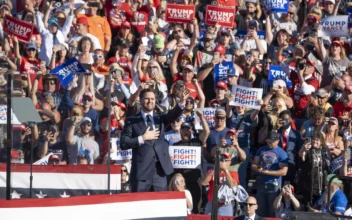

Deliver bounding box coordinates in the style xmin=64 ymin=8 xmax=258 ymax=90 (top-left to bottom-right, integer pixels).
xmin=297 ymin=131 xmax=332 ymax=207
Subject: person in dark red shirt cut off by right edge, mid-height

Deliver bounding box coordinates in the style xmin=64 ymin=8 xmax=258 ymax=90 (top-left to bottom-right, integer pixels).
xmin=333 ymin=86 xmax=352 ymax=129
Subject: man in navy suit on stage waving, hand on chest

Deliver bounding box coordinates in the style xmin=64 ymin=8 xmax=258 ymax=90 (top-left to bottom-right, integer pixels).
xmin=120 ymin=89 xmax=189 ymax=192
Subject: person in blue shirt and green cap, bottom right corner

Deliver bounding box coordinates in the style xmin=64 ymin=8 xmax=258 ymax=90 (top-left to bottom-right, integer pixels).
xmin=310 ymin=174 xmax=348 ymax=215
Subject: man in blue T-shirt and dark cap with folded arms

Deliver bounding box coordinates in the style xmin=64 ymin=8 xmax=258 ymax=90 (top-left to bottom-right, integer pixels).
xmin=252 ymin=131 xmax=288 ymax=217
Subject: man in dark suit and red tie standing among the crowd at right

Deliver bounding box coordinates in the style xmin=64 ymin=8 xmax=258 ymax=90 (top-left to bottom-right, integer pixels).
xmin=277 ymin=110 xmax=303 ymax=184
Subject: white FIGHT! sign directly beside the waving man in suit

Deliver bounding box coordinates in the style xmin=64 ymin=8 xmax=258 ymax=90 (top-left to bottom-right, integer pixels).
xmin=169 ymin=146 xmax=202 ymax=169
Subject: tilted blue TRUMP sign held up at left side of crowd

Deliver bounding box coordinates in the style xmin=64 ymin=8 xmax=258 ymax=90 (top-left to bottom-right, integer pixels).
xmin=50 ymin=58 xmax=86 ymax=88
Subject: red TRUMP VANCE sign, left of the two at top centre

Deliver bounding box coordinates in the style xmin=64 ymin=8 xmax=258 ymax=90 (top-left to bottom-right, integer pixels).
xmin=166 ymin=4 xmax=196 ymax=23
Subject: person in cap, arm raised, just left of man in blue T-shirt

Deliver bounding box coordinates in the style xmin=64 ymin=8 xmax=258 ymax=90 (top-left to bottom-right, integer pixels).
xmin=211 ymin=129 xmax=247 ymax=173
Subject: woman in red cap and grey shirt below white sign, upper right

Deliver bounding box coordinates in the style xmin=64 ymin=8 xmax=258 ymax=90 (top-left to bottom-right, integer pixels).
xmin=320 ymin=40 xmax=350 ymax=87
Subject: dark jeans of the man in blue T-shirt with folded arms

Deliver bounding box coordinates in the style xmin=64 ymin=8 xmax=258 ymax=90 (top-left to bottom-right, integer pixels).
xmin=257 ymin=190 xmax=280 ymax=218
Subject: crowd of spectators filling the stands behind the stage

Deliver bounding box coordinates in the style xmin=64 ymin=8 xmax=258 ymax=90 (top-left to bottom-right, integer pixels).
xmin=0 ymin=0 xmax=352 ymax=219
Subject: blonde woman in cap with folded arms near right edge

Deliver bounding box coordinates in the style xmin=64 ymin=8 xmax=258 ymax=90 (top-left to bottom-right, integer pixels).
xmin=324 ymin=117 xmax=344 ymax=158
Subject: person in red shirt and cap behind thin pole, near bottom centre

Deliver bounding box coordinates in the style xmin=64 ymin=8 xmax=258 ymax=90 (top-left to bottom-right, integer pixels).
xmin=201 ymin=152 xmax=240 ymax=216
